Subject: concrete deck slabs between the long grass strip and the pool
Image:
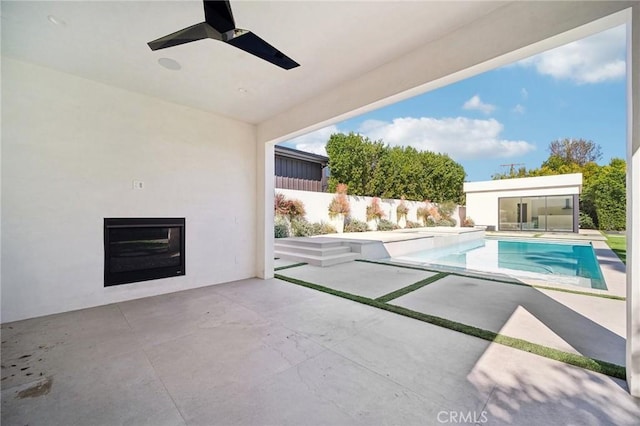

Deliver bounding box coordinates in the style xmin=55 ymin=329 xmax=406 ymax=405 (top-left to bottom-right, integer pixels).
xmin=277 ymin=262 xmax=626 ymax=365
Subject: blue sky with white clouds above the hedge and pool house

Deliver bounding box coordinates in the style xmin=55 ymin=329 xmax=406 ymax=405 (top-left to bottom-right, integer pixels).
xmin=283 ymin=26 xmax=626 ymax=181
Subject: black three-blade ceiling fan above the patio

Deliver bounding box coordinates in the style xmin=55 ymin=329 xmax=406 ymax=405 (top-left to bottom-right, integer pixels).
xmin=147 ymin=0 xmax=300 ymax=70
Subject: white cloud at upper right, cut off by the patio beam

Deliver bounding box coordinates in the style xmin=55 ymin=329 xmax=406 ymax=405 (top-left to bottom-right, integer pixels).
xmin=517 ymin=25 xmax=626 ymax=84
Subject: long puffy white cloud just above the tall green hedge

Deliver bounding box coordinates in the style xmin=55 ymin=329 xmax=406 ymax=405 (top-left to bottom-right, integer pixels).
xmin=360 ymin=117 xmax=535 ymax=160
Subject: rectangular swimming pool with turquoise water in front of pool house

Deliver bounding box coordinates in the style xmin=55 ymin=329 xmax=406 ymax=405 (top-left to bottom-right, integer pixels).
xmin=394 ymin=238 xmax=607 ymax=290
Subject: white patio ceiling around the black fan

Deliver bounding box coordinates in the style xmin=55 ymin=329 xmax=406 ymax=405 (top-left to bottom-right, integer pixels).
xmin=1 ymin=0 xmax=508 ymax=123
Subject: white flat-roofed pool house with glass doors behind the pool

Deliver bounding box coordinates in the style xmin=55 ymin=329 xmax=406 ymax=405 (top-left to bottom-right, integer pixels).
xmin=464 ymin=173 xmax=582 ymax=232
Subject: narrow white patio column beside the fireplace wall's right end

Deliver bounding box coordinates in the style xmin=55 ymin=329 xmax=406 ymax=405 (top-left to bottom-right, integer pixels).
xmin=256 ymin=140 xmax=275 ymax=279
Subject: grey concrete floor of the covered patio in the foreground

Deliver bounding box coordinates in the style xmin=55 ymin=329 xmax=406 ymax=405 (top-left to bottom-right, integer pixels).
xmin=1 ymin=274 xmax=640 ymax=426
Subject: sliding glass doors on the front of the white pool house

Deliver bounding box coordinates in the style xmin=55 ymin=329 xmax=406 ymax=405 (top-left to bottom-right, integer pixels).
xmin=498 ymin=195 xmax=578 ymax=232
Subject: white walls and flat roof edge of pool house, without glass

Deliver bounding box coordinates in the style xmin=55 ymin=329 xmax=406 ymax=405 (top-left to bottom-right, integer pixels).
xmin=464 ymin=173 xmax=582 ymax=231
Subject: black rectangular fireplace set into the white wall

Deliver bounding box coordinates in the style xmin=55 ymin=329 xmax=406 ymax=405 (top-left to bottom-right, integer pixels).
xmin=104 ymin=218 xmax=185 ymax=287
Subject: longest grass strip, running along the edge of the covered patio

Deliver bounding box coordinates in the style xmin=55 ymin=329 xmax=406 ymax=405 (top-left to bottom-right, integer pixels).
xmin=275 ymin=274 xmax=626 ymax=380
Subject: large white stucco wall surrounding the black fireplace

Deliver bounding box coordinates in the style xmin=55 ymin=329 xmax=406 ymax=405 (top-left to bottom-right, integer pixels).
xmin=1 ymin=58 xmax=256 ymax=322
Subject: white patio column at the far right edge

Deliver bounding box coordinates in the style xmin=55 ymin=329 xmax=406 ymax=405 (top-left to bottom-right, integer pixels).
xmin=626 ymin=5 xmax=640 ymax=397
